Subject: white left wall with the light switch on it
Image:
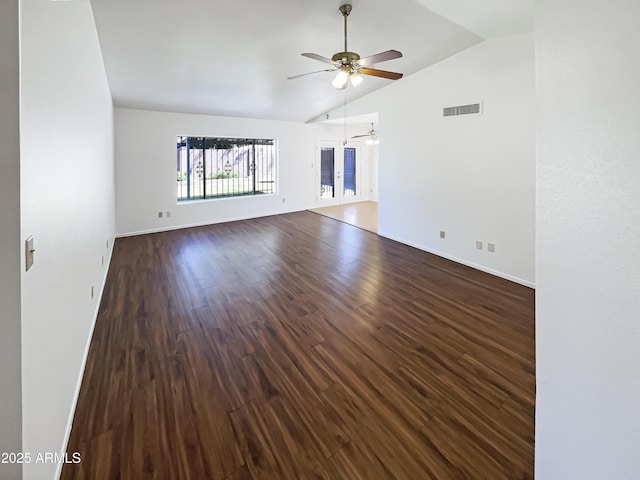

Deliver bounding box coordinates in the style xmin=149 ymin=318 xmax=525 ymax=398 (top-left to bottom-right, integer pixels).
xmin=21 ymin=0 xmax=115 ymax=480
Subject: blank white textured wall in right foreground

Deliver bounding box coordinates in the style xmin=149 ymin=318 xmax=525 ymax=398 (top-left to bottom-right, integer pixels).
xmin=535 ymin=0 xmax=640 ymax=480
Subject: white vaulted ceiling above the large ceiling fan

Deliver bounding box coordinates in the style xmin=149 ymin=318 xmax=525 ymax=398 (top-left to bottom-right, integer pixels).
xmin=91 ymin=0 xmax=533 ymax=121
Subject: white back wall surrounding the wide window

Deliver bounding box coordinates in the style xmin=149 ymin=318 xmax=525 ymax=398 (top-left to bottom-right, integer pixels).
xmin=115 ymin=108 xmax=341 ymax=235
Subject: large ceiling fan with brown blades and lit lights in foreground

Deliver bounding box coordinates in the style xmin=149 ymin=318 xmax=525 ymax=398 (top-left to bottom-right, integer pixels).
xmin=288 ymin=3 xmax=402 ymax=90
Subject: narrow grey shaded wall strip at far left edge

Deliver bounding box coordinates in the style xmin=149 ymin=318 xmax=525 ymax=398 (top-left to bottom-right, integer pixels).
xmin=0 ymin=0 xmax=22 ymax=479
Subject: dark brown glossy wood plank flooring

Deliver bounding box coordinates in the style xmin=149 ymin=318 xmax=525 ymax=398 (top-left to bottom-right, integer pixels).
xmin=62 ymin=212 xmax=535 ymax=480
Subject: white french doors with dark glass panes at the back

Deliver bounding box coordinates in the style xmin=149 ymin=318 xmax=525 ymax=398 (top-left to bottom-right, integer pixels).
xmin=316 ymin=142 xmax=362 ymax=206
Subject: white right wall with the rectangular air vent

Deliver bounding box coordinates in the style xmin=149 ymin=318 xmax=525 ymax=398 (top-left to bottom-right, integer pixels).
xmin=318 ymin=34 xmax=535 ymax=286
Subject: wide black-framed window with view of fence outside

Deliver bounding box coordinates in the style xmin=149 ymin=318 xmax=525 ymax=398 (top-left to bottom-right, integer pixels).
xmin=176 ymin=136 xmax=277 ymax=201
